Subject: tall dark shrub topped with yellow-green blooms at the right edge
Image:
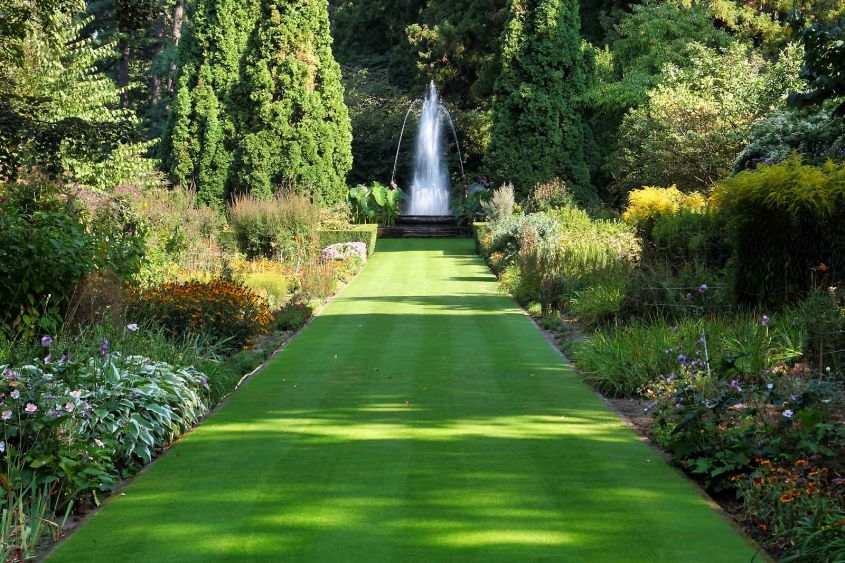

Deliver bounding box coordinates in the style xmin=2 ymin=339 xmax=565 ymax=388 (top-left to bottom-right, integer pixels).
xmin=714 ymin=157 xmax=845 ymax=303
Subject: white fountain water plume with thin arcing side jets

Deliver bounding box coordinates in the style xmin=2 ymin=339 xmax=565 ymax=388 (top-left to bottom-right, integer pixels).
xmin=391 ymin=82 xmax=466 ymax=217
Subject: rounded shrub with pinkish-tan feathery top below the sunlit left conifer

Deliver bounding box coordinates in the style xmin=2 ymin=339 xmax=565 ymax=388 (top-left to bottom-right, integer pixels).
xmin=229 ymin=192 xmax=319 ymax=260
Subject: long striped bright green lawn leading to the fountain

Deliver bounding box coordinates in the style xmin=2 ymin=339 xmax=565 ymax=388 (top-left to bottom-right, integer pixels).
xmin=51 ymin=240 xmax=753 ymax=562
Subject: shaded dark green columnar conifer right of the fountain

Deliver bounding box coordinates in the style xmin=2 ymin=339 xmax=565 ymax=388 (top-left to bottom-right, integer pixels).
xmin=485 ymin=0 xmax=593 ymax=199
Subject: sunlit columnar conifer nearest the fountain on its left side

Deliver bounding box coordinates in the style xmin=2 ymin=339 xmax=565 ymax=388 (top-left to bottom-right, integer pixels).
xmin=234 ymin=0 xmax=352 ymax=203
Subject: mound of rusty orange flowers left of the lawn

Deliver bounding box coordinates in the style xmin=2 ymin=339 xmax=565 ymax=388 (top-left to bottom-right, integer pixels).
xmin=127 ymin=279 xmax=272 ymax=350
